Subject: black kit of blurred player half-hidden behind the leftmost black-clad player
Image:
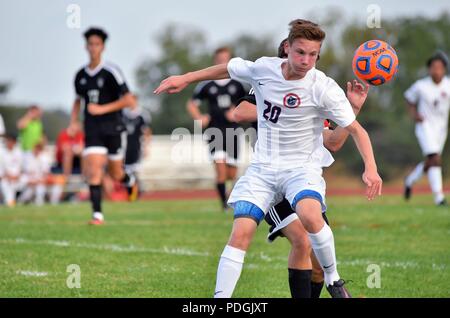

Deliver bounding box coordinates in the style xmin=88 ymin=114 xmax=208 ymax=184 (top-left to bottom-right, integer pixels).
xmin=123 ymin=109 xmax=151 ymax=164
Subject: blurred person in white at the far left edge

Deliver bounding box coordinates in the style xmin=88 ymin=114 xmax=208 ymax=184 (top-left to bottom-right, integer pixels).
xmin=0 ymin=135 xmax=23 ymax=207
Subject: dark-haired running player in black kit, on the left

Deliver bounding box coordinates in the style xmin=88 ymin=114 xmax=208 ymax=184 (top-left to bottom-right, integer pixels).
xmin=71 ymin=28 xmax=138 ymax=225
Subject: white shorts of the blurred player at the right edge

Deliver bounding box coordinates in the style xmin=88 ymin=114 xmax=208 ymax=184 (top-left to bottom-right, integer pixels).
xmin=416 ymin=123 xmax=447 ymax=156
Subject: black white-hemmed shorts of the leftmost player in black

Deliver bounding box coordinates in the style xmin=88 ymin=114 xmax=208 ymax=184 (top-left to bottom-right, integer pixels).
xmin=83 ymin=123 xmax=127 ymax=160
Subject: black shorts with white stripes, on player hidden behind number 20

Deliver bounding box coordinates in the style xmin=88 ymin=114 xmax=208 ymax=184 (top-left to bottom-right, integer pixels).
xmin=264 ymin=199 xmax=330 ymax=242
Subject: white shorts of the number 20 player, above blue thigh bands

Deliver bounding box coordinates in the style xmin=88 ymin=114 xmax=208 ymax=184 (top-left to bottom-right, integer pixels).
xmin=228 ymin=165 xmax=326 ymax=214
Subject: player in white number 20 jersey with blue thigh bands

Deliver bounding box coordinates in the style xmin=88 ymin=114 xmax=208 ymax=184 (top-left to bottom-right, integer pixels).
xmin=154 ymin=20 xmax=382 ymax=297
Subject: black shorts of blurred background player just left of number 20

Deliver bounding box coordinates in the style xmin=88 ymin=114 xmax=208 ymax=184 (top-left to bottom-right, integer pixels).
xmin=206 ymin=128 xmax=239 ymax=166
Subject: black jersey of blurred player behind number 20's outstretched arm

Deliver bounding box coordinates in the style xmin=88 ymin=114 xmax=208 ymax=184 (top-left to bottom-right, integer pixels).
xmin=192 ymin=80 xmax=245 ymax=129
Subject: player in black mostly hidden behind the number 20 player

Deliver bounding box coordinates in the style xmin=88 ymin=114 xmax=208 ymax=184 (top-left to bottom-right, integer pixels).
xmin=233 ymin=39 xmax=368 ymax=298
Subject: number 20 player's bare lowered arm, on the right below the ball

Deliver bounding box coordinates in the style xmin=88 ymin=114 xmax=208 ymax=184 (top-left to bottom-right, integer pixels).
xmin=345 ymin=120 xmax=383 ymax=200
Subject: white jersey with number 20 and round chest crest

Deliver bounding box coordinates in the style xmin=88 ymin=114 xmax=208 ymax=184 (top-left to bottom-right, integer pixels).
xmin=228 ymin=57 xmax=355 ymax=169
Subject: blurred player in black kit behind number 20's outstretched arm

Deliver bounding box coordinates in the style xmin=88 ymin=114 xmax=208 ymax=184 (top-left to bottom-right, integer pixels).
xmin=187 ymin=47 xmax=245 ymax=210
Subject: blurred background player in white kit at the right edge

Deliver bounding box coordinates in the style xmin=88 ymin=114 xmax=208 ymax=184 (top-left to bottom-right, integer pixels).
xmin=404 ymin=51 xmax=450 ymax=206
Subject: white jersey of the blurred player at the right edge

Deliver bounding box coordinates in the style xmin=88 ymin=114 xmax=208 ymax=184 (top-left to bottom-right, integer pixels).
xmin=405 ymin=76 xmax=450 ymax=133
